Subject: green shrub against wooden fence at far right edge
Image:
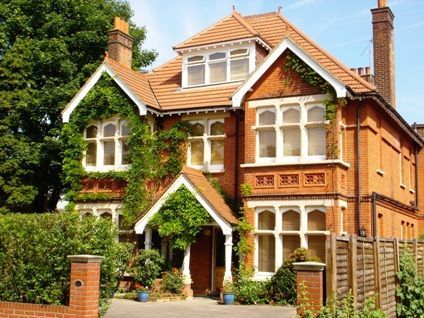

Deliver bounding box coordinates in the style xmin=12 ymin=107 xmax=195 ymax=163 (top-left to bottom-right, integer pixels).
xmin=396 ymin=248 xmax=424 ymax=317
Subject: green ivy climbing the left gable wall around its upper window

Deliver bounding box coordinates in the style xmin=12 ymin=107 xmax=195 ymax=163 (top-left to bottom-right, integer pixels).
xmin=62 ymin=74 xmax=188 ymax=225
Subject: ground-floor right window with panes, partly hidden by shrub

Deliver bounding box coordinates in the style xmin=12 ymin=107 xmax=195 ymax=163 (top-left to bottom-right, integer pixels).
xmin=253 ymin=200 xmax=332 ymax=279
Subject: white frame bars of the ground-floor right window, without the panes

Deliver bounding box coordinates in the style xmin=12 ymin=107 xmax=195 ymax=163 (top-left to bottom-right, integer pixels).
xmin=252 ymin=199 xmax=334 ymax=280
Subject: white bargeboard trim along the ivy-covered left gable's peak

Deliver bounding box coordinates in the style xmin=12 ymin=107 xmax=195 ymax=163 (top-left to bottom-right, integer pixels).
xmin=62 ymin=62 xmax=147 ymax=123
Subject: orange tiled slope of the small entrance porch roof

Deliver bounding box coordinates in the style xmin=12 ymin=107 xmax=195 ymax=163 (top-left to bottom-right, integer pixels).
xmin=181 ymin=167 xmax=238 ymax=224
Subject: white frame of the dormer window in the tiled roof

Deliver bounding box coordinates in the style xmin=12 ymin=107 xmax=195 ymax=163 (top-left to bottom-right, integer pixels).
xmin=181 ymin=43 xmax=256 ymax=88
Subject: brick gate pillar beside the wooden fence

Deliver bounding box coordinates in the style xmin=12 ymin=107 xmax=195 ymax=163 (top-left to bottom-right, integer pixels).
xmin=293 ymin=262 xmax=325 ymax=310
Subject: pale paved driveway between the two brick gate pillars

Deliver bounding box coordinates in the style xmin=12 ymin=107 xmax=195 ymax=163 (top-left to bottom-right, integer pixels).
xmin=104 ymin=298 xmax=296 ymax=318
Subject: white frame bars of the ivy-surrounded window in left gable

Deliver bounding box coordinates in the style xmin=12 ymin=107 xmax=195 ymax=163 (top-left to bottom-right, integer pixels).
xmin=82 ymin=117 xmax=130 ymax=172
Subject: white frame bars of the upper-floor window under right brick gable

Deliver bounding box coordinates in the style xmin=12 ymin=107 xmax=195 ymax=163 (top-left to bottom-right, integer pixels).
xmin=252 ymin=94 xmax=328 ymax=164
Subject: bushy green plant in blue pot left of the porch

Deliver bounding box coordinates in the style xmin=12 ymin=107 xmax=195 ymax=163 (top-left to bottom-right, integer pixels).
xmin=132 ymin=250 xmax=165 ymax=302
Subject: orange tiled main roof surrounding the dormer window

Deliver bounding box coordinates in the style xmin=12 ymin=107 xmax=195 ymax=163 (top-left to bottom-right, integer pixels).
xmin=107 ymin=12 xmax=375 ymax=111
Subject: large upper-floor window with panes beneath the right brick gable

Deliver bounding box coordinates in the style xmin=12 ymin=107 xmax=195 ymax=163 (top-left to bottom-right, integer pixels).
xmin=253 ymin=97 xmax=326 ymax=163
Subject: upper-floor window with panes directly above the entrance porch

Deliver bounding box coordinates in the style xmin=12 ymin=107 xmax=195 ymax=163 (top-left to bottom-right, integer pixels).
xmin=187 ymin=119 xmax=225 ymax=171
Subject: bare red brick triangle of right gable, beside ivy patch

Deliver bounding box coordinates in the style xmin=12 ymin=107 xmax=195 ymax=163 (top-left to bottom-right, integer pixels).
xmin=246 ymin=50 xmax=323 ymax=100
